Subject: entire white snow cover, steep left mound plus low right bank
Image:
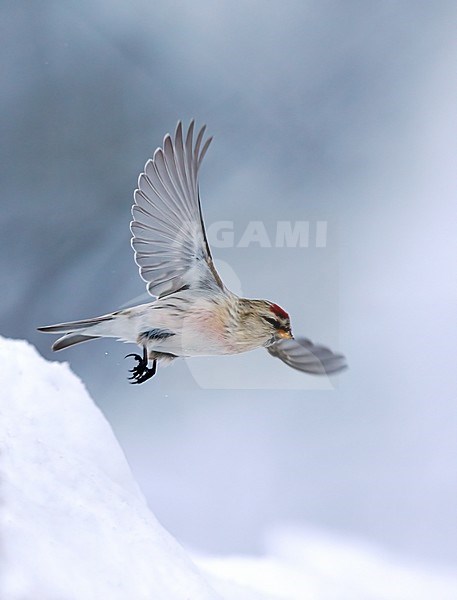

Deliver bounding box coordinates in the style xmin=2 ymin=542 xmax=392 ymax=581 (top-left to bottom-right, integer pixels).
xmin=0 ymin=338 xmax=457 ymax=600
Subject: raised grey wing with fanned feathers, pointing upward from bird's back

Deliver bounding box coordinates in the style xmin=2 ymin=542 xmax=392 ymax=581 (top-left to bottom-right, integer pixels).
xmin=130 ymin=121 xmax=223 ymax=297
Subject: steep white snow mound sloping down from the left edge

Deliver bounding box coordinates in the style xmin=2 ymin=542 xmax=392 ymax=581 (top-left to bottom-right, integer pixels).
xmin=0 ymin=338 xmax=220 ymax=600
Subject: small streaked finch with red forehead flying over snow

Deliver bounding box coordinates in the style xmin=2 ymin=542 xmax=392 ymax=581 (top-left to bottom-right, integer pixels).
xmin=38 ymin=120 xmax=347 ymax=384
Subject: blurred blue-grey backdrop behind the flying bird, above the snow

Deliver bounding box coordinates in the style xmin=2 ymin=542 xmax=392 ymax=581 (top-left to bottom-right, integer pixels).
xmin=0 ymin=0 xmax=457 ymax=565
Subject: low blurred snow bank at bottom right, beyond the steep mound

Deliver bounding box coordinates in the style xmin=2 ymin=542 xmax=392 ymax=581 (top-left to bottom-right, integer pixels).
xmin=197 ymin=527 xmax=457 ymax=600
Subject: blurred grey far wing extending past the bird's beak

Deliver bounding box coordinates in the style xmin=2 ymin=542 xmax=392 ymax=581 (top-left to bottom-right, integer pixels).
xmin=267 ymin=338 xmax=347 ymax=375
